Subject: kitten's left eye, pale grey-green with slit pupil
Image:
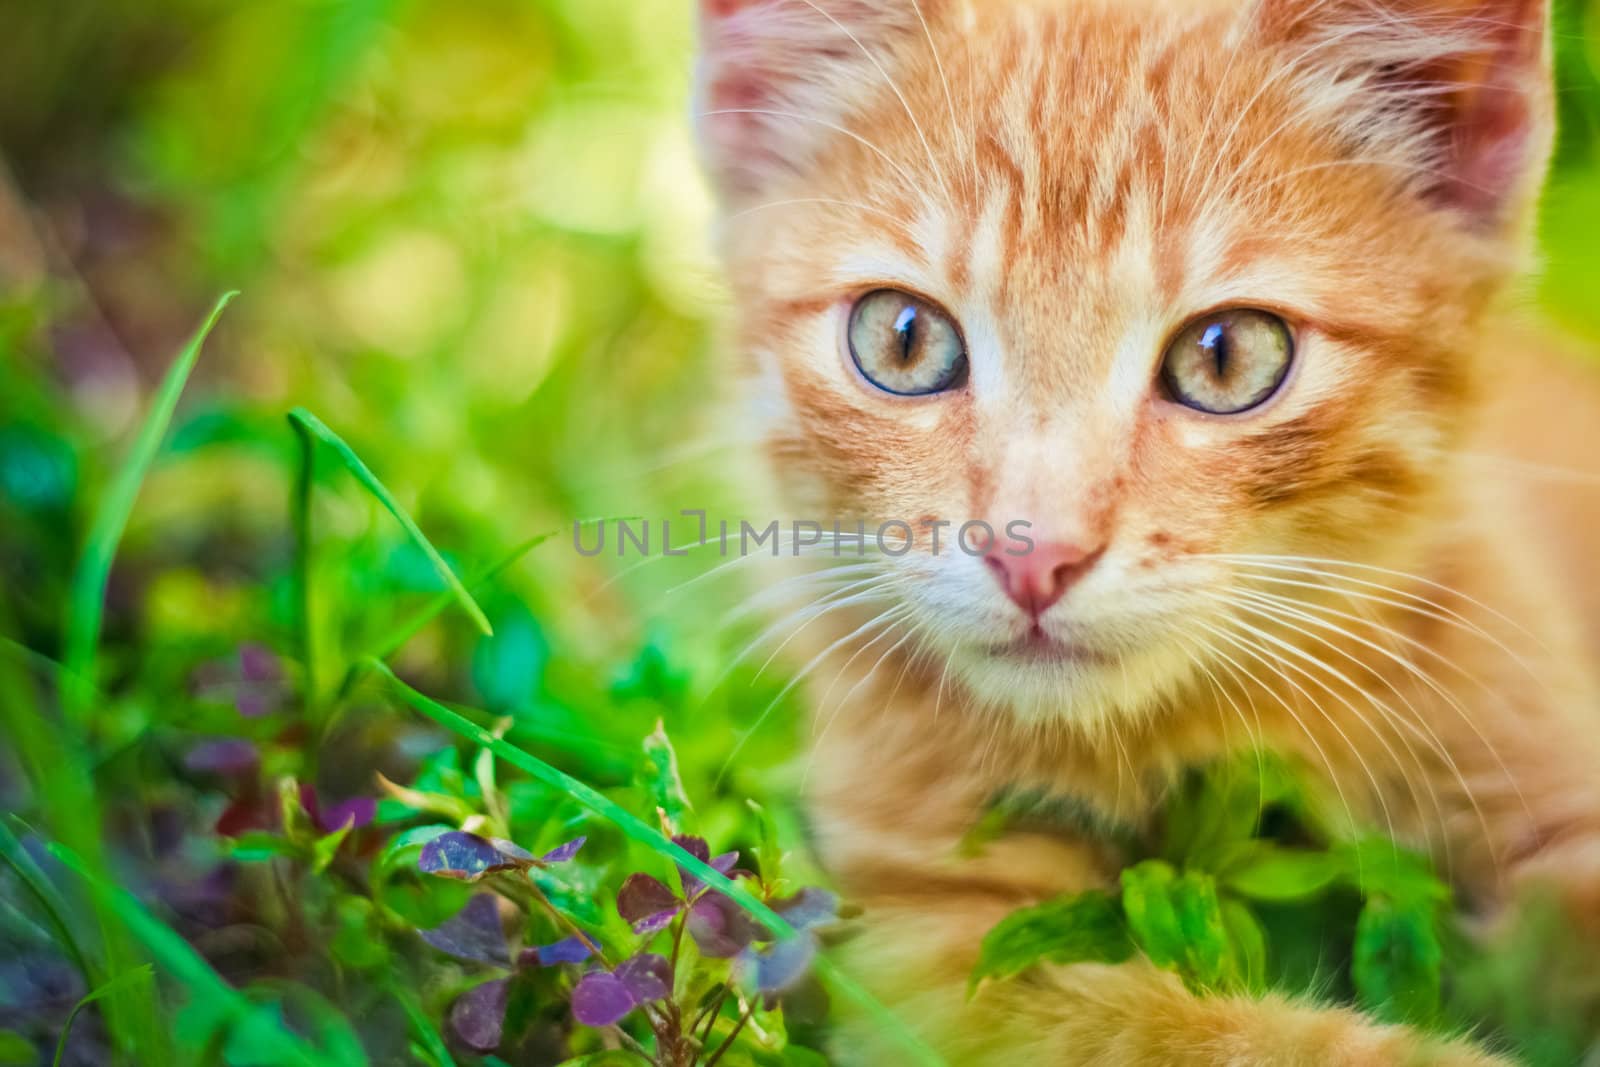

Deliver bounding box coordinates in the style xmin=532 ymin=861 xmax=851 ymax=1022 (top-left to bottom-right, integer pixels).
xmin=850 ymin=290 xmax=966 ymax=397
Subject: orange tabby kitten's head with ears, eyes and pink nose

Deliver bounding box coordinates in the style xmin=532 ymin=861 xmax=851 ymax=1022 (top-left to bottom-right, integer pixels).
xmin=699 ymin=0 xmax=1550 ymax=718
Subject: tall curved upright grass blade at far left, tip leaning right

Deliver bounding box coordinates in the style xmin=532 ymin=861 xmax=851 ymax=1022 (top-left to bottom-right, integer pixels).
xmin=62 ymin=293 xmax=237 ymax=728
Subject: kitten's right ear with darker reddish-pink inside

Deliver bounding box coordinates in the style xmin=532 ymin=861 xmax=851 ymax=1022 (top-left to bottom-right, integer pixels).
xmin=1258 ymin=0 xmax=1554 ymax=230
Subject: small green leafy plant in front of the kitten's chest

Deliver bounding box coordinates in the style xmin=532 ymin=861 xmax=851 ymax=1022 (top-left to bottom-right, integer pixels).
xmin=971 ymin=757 xmax=1459 ymax=1025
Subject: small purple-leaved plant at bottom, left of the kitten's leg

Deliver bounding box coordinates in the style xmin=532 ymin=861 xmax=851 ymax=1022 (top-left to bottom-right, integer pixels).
xmin=418 ymin=832 xmax=838 ymax=1067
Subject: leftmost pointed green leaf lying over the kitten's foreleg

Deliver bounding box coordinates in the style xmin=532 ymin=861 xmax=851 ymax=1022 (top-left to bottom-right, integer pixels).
xmin=968 ymin=889 xmax=1133 ymax=990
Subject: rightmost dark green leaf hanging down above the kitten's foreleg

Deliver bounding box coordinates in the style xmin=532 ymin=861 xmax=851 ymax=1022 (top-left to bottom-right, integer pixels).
xmin=1350 ymin=896 xmax=1443 ymax=1024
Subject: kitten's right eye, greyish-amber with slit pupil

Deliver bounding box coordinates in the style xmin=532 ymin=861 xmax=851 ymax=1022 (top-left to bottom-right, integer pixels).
xmin=1162 ymin=309 xmax=1294 ymax=414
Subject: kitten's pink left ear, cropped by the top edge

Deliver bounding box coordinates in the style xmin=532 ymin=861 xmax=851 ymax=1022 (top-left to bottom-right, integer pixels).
xmin=696 ymin=0 xmax=933 ymax=202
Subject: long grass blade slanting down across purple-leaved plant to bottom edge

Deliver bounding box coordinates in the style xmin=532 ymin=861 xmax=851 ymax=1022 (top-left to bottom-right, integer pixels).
xmin=366 ymin=659 xmax=944 ymax=1065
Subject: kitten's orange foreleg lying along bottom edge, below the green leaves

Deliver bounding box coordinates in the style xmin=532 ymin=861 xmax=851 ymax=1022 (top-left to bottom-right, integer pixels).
xmin=837 ymin=893 xmax=1502 ymax=1067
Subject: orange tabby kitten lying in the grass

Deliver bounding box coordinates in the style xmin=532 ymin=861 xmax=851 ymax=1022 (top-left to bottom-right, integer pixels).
xmin=699 ymin=0 xmax=1600 ymax=1064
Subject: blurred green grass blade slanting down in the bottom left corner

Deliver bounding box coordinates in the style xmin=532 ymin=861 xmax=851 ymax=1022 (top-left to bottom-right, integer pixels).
xmin=50 ymin=843 xmax=341 ymax=1067
